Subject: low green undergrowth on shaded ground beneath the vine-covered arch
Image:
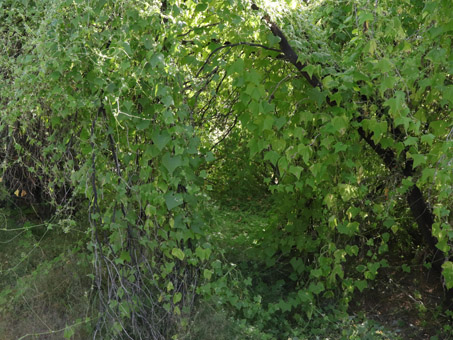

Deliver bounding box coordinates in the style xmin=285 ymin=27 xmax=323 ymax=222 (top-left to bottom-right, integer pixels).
xmin=195 ymin=199 xmax=399 ymax=340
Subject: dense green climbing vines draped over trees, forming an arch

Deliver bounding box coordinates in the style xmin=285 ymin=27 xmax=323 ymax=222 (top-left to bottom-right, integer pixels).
xmin=0 ymin=0 xmax=453 ymax=339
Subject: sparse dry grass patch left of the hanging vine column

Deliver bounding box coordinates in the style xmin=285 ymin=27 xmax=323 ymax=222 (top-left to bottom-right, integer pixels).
xmin=0 ymin=209 xmax=91 ymax=340
